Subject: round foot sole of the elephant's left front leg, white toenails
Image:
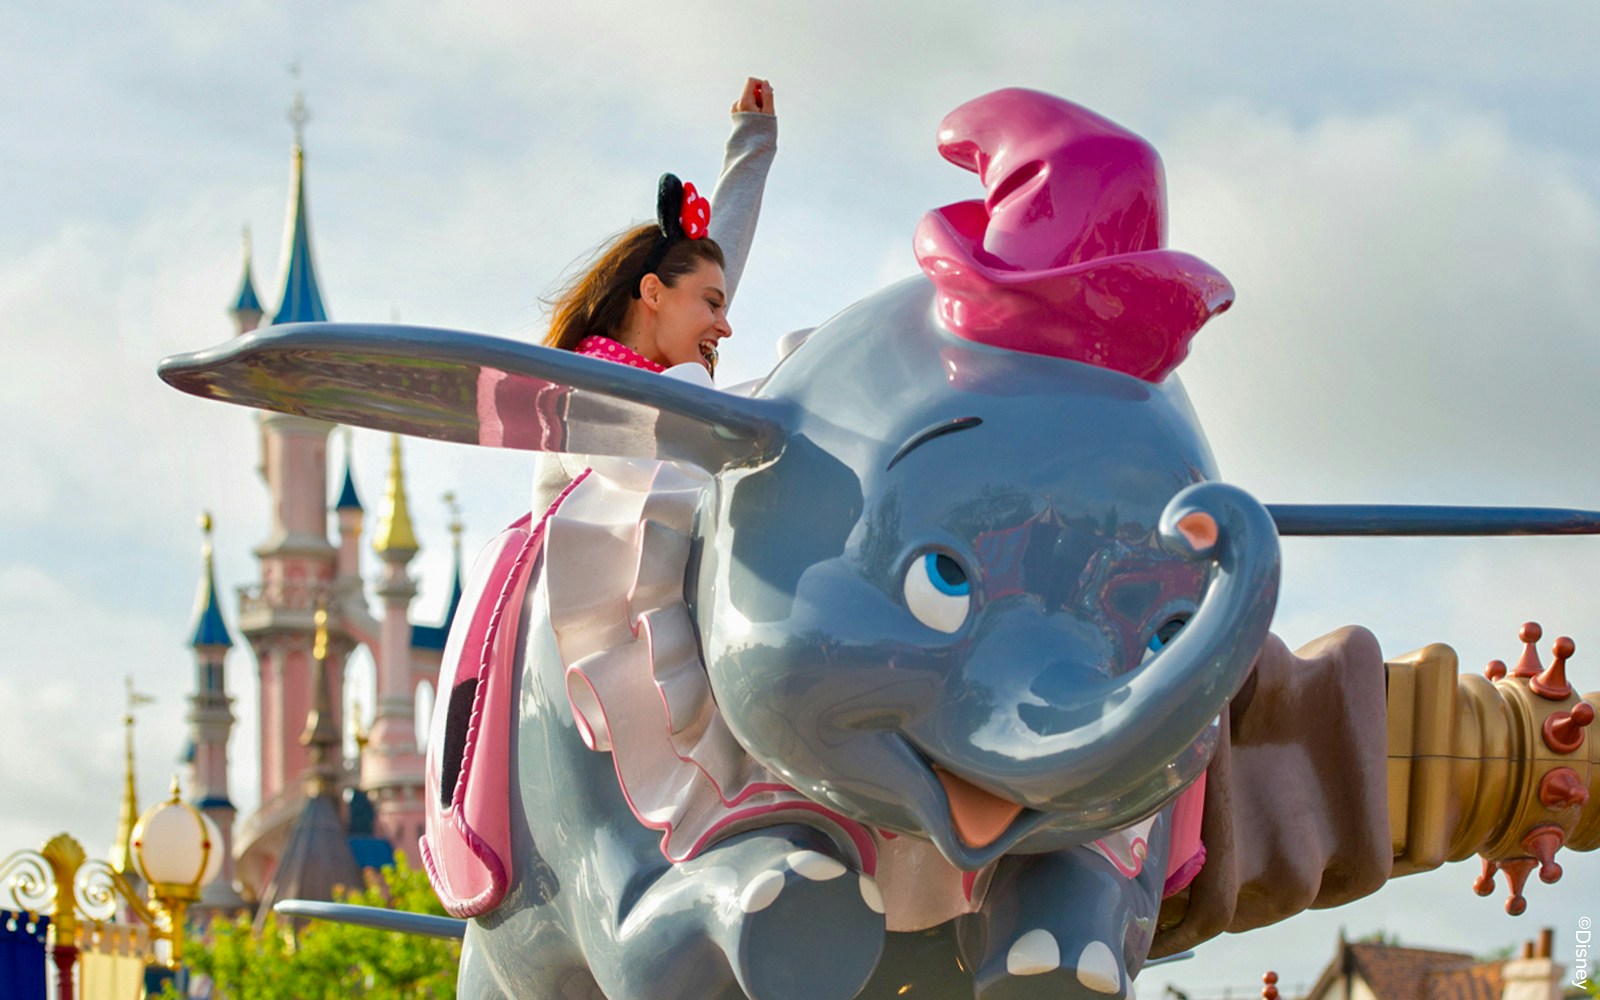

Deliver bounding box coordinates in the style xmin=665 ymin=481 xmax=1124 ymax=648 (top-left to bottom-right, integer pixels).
xmin=725 ymin=843 xmax=885 ymax=1000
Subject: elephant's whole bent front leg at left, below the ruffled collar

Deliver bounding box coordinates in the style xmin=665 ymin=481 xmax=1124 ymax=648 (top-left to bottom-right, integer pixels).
xmin=587 ymin=826 xmax=885 ymax=1000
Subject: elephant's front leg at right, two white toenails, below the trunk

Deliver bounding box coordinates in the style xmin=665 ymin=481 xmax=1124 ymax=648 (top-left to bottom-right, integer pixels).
xmin=962 ymin=816 xmax=1166 ymax=1000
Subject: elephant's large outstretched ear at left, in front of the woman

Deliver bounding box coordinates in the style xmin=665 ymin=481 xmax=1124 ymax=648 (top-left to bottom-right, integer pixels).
xmin=160 ymin=323 xmax=786 ymax=472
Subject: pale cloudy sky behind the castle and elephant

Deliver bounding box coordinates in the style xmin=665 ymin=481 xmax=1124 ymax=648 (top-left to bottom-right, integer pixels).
xmin=0 ymin=0 xmax=1600 ymax=997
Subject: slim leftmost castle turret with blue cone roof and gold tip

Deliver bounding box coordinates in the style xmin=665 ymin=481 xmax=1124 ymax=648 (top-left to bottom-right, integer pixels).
xmin=187 ymin=514 xmax=245 ymax=909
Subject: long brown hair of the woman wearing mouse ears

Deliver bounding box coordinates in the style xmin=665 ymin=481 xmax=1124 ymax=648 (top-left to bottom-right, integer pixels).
xmin=544 ymin=224 xmax=726 ymax=350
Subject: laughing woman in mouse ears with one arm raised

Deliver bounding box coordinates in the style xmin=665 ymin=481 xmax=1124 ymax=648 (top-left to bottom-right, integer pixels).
xmin=544 ymin=77 xmax=778 ymax=381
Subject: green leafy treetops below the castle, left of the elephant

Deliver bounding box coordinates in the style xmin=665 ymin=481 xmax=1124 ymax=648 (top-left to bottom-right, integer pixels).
xmin=184 ymin=858 xmax=461 ymax=1000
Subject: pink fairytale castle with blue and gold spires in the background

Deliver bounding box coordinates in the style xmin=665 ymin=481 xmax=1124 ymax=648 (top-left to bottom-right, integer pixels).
xmin=132 ymin=98 xmax=461 ymax=909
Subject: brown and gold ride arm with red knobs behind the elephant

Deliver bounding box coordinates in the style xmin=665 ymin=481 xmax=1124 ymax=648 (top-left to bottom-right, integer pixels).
xmin=1150 ymin=624 xmax=1600 ymax=957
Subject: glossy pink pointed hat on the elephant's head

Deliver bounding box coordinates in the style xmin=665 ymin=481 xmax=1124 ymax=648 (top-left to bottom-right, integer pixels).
xmin=915 ymin=90 xmax=1234 ymax=382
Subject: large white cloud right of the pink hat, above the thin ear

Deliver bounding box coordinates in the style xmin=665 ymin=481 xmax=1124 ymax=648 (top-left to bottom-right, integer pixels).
xmin=1166 ymin=100 xmax=1600 ymax=506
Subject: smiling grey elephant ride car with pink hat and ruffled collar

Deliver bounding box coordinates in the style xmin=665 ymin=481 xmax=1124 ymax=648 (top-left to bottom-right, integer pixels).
xmin=162 ymin=90 xmax=1589 ymax=1000
